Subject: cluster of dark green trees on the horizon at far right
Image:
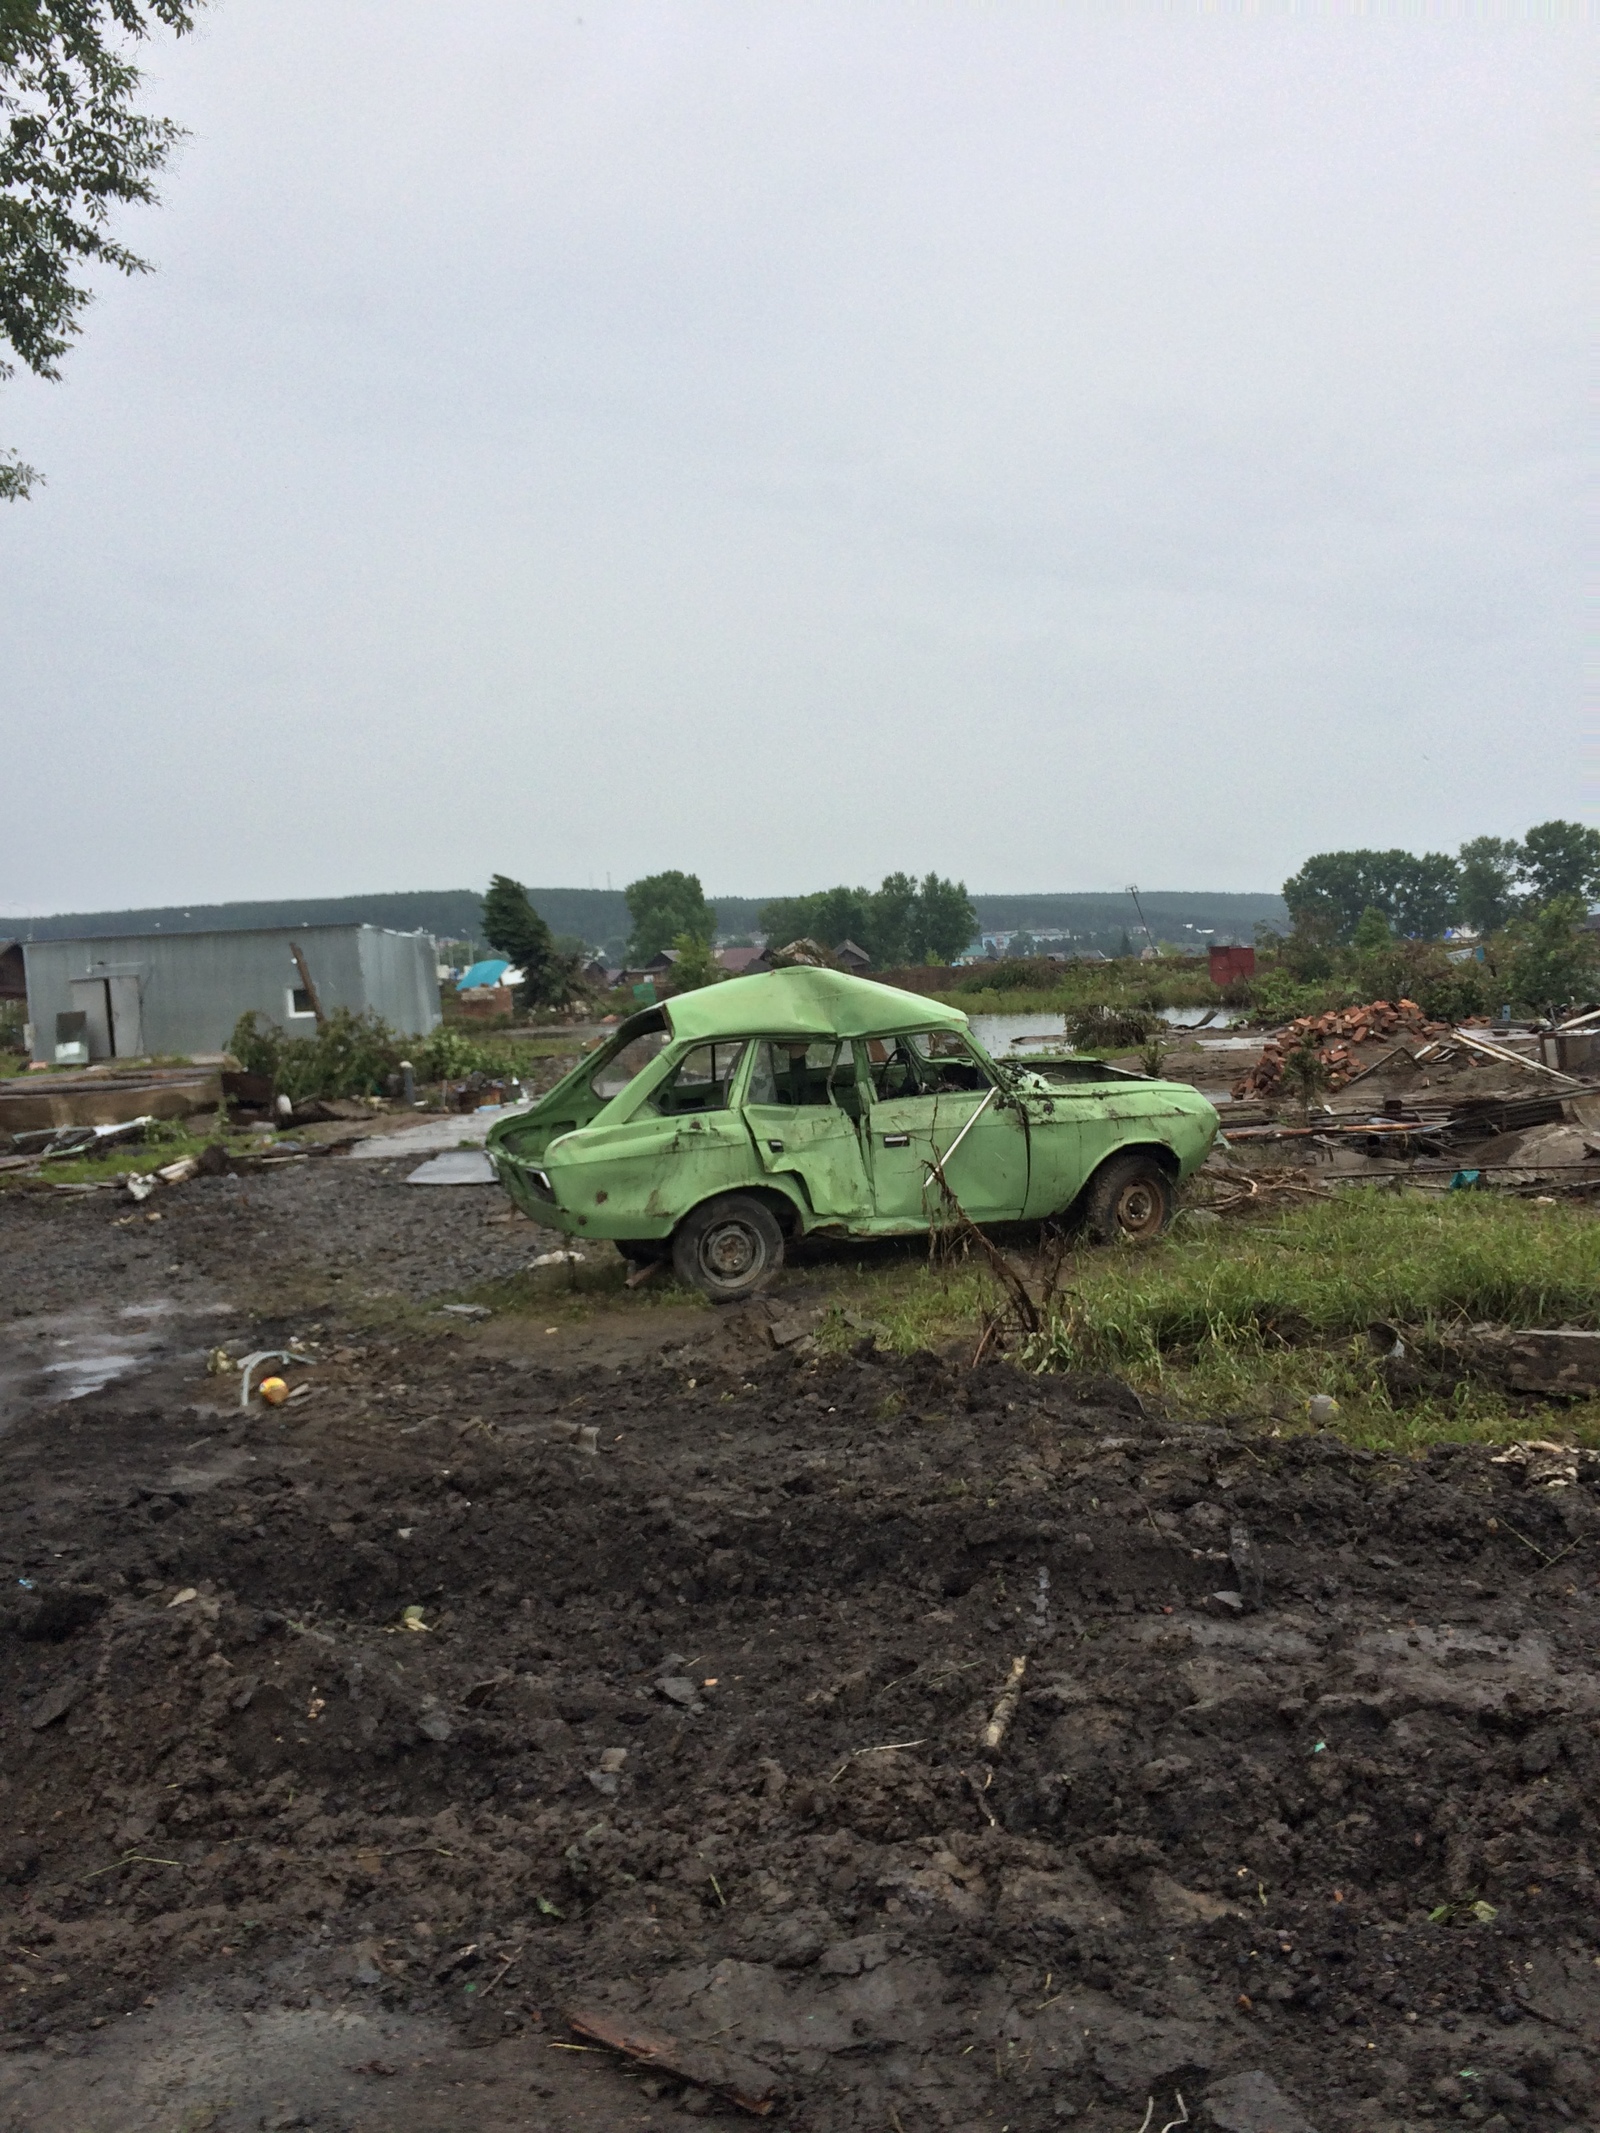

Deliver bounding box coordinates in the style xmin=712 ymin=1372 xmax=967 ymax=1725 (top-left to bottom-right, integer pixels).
xmin=1284 ymin=821 xmax=1600 ymax=947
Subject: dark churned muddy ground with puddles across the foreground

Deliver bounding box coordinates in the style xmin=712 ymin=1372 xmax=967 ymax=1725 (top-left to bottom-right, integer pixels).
xmin=0 ymin=1160 xmax=1600 ymax=2133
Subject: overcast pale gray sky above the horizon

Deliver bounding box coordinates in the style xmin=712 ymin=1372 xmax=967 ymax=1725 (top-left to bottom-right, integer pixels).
xmin=0 ymin=0 xmax=1596 ymax=913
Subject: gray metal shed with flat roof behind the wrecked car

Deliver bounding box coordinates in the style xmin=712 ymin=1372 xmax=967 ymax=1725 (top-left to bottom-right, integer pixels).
xmin=23 ymin=926 xmax=439 ymax=1062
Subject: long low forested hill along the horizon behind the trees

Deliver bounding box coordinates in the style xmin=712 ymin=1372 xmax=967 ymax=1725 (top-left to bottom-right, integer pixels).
xmin=0 ymin=889 xmax=1289 ymax=945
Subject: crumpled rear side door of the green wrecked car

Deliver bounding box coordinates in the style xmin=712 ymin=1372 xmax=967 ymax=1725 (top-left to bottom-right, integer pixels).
xmin=745 ymin=1037 xmax=873 ymax=1220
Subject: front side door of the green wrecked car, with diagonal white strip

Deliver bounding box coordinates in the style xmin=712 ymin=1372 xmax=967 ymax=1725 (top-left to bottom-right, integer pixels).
xmin=862 ymin=1030 xmax=1028 ymax=1229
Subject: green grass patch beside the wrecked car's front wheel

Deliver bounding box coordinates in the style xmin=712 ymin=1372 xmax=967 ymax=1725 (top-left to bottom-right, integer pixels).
xmin=826 ymin=1188 xmax=1600 ymax=1450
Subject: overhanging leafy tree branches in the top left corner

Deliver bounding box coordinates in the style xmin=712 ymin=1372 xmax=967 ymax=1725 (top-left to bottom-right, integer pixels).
xmin=0 ymin=0 xmax=203 ymax=499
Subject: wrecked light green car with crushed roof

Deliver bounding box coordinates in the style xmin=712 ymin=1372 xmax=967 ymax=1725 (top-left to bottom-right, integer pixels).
xmin=489 ymin=968 xmax=1218 ymax=1301
